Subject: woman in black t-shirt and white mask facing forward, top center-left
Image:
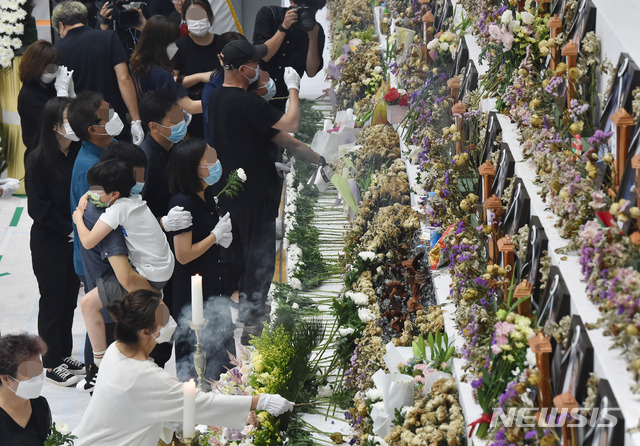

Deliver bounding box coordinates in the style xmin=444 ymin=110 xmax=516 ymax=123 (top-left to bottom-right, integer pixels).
xmin=171 ymin=0 xmax=224 ymax=138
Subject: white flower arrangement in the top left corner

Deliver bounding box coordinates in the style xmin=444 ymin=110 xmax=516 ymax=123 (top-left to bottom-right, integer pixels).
xmin=0 ymin=0 xmax=37 ymax=68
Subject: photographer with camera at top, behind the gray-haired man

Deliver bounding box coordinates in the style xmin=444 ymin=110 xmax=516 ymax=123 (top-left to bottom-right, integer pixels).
xmin=97 ymin=0 xmax=147 ymax=56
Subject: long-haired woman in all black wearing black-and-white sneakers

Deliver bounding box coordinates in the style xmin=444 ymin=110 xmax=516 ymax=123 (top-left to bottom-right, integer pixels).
xmin=25 ymin=97 xmax=84 ymax=387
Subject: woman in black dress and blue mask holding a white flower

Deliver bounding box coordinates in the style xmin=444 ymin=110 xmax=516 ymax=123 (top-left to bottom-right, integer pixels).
xmin=167 ymin=138 xmax=238 ymax=380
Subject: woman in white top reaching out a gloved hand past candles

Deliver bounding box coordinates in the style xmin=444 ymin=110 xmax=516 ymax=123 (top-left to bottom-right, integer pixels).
xmin=73 ymin=290 xmax=293 ymax=446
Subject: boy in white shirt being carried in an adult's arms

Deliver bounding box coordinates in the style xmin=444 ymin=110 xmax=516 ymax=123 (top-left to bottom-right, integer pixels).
xmin=73 ymin=159 xmax=175 ymax=386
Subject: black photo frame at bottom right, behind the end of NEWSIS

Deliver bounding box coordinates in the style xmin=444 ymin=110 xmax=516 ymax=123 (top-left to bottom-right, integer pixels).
xmin=578 ymin=379 xmax=625 ymax=446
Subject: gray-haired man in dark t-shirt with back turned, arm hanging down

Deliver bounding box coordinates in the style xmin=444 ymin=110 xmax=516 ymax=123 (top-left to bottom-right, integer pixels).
xmin=51 ymin=1 xmax=144 ymax=144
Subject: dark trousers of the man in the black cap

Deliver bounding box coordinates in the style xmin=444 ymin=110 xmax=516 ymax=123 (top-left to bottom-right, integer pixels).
xmin=229 ymin=202 xmax=277 ymax=325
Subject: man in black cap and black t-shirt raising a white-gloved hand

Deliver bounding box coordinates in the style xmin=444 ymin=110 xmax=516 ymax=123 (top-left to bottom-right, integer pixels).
xmin=209 ymin=40 xmax=320 ymax=342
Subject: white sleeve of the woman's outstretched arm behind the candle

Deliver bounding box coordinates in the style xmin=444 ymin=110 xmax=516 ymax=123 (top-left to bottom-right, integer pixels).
xmin=139 ymin=365 xmax=252 ymax=429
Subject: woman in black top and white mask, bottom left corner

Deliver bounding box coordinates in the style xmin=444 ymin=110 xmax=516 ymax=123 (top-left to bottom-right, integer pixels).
xmin=0 ymin=334 xmax=51 ymax=446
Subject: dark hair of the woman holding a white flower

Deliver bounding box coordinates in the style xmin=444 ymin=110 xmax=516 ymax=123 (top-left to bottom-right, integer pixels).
xmin=167 ymin=138 xmax=207 ymax=195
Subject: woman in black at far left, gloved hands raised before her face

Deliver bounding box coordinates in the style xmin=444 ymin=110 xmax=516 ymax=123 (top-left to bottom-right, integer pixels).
xmin=18 ymin=40 xmax=62 ymax=158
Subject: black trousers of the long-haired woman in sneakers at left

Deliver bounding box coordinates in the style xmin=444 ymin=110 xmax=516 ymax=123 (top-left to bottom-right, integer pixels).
xmin=30 ymin=225 xmax=80 ymax=368
